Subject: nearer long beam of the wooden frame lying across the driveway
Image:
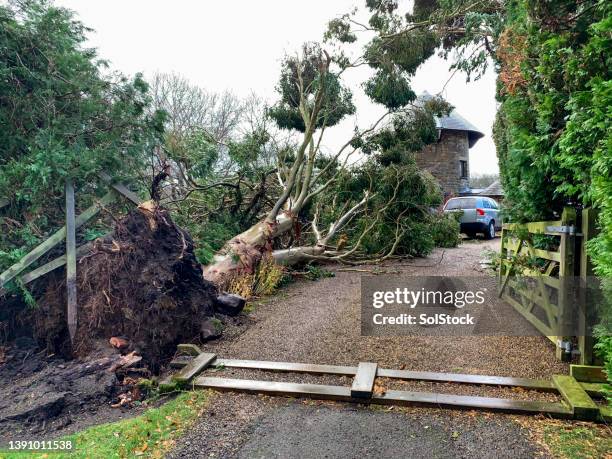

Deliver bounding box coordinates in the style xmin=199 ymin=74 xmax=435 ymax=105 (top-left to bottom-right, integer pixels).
xmin=194 ymin=376 xmax=572 ymax=418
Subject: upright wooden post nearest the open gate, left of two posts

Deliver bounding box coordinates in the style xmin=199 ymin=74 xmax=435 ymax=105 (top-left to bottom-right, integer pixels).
xmin=556 ymin=207 xmax=576 ymax=361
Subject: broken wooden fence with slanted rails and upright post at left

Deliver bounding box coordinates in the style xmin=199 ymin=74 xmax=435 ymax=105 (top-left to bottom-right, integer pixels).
xmin=0 ymin=173 xmax=141 ymax=340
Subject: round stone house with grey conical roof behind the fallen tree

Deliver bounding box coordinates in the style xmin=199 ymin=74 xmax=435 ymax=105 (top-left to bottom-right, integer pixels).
xmin=415 ymin=93 xmax=484 ymax=201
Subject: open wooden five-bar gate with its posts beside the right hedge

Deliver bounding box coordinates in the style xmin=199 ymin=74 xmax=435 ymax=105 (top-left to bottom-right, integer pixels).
xmin=499 ymin=207 xmax=595 ymax=364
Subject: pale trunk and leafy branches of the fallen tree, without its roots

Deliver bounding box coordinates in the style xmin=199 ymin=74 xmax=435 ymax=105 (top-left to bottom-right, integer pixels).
xmin=203 ymin=44 xmax=449 ymax=288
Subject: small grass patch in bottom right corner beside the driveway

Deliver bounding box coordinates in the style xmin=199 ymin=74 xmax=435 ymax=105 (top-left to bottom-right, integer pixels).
xmin=543 ymin=424 xmax=612 ymax=459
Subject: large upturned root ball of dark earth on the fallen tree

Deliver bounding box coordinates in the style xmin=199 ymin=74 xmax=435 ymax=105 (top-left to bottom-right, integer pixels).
xmin=35 ymin=203 xmax=217 ymax=372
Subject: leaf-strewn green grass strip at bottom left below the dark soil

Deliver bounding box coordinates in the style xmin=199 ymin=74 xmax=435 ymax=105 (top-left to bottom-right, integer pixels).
xmin=0 ymin=391 xmax=206 ymax=459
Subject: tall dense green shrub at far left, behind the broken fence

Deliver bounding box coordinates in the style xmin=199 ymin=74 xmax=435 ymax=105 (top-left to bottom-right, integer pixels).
xmin=0 ymin=0 xmax=164 ymax=270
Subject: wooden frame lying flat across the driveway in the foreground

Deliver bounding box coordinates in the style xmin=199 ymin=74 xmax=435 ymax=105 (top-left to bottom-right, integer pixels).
xmin=160 ymin=345 xmax=608 ymax=421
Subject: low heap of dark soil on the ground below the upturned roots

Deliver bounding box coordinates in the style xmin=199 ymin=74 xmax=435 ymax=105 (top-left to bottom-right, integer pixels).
xmin=0 ymin=338 xmax=158 ymax=449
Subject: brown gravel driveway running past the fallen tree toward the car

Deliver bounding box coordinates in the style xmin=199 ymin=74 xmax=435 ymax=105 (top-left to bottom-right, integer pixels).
xmin=170 ymin=239 xmax=567 ymax=458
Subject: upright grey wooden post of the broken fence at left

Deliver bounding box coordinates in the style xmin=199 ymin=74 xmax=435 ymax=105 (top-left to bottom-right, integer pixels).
xmin=65 ymin=180 xmax=77 ymax=343
